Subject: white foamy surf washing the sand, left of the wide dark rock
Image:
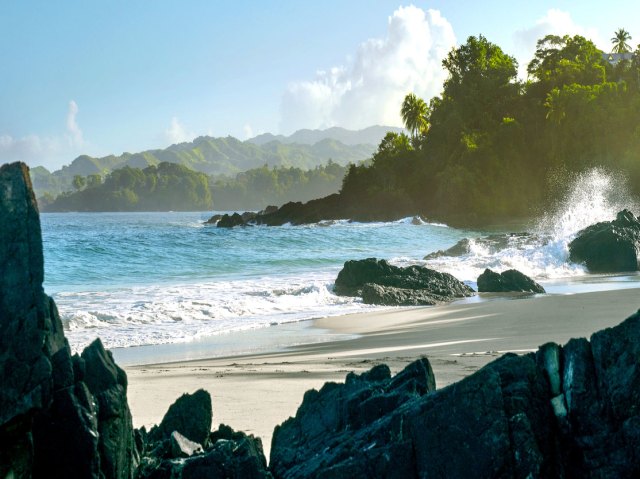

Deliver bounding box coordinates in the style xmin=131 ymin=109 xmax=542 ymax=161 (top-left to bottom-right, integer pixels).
xmin=54 ymin=273 xmax=372 ymax=351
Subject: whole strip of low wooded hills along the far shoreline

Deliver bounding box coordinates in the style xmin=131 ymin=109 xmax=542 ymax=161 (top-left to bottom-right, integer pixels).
xmin=39 ymin=160 xmax=346 ymax=211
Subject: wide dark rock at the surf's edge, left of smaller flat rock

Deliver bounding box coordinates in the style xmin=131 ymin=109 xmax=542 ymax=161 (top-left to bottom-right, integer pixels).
xmin=334 ymin=258 xmax=474 ymax=305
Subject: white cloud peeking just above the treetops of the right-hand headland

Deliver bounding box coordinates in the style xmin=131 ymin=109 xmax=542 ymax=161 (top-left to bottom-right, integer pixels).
xmin=513 ymin=8 xmax=607 ymax=78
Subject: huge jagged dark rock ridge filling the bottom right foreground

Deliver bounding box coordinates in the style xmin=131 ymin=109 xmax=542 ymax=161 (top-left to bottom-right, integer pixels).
xmin=270 ymin=313 xmax=640 ymax=479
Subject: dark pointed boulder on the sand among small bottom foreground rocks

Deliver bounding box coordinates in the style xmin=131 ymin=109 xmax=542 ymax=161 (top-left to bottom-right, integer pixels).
xmin=149 ymin=389 xmax=213 ymax=446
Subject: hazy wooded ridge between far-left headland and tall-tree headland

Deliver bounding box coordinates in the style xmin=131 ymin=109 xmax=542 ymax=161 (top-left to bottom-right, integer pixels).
xmin=211 ymin=160 xmax=346 ymax=210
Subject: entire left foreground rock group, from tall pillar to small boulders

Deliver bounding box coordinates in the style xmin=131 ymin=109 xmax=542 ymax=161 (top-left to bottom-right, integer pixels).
xmin=0 ymin=163 xmax=271 ymax=479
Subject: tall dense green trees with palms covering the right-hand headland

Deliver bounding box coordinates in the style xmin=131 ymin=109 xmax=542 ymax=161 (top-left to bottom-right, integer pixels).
xmin=341 ymin=30 xmax=640 ymax=224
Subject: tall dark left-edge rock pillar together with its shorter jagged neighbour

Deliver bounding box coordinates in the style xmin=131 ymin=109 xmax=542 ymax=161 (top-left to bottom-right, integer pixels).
xmin=0 ymin=163 xmax=136 ymax=479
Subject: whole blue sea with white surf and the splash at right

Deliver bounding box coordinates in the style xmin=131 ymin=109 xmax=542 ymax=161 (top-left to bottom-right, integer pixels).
xmin=41 ymin=171 xmax=640 ymax=351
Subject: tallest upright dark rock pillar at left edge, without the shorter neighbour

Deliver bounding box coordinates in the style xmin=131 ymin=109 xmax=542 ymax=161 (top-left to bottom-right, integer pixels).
xmin=0 ymin=163 xmax=69 ymax=477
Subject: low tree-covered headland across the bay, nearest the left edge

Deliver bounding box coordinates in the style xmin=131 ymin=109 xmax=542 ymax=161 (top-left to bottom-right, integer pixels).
xmin=40 ymin=162 xmax=213 ymax=211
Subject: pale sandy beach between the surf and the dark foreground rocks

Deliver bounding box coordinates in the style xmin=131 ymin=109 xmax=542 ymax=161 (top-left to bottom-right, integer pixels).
xmin=124 ymin=289 xmax=640 ymax=457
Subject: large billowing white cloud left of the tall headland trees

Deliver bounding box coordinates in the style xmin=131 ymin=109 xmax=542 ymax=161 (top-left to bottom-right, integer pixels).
xmin=281 ymin=6 xmax=456 ymax=133
